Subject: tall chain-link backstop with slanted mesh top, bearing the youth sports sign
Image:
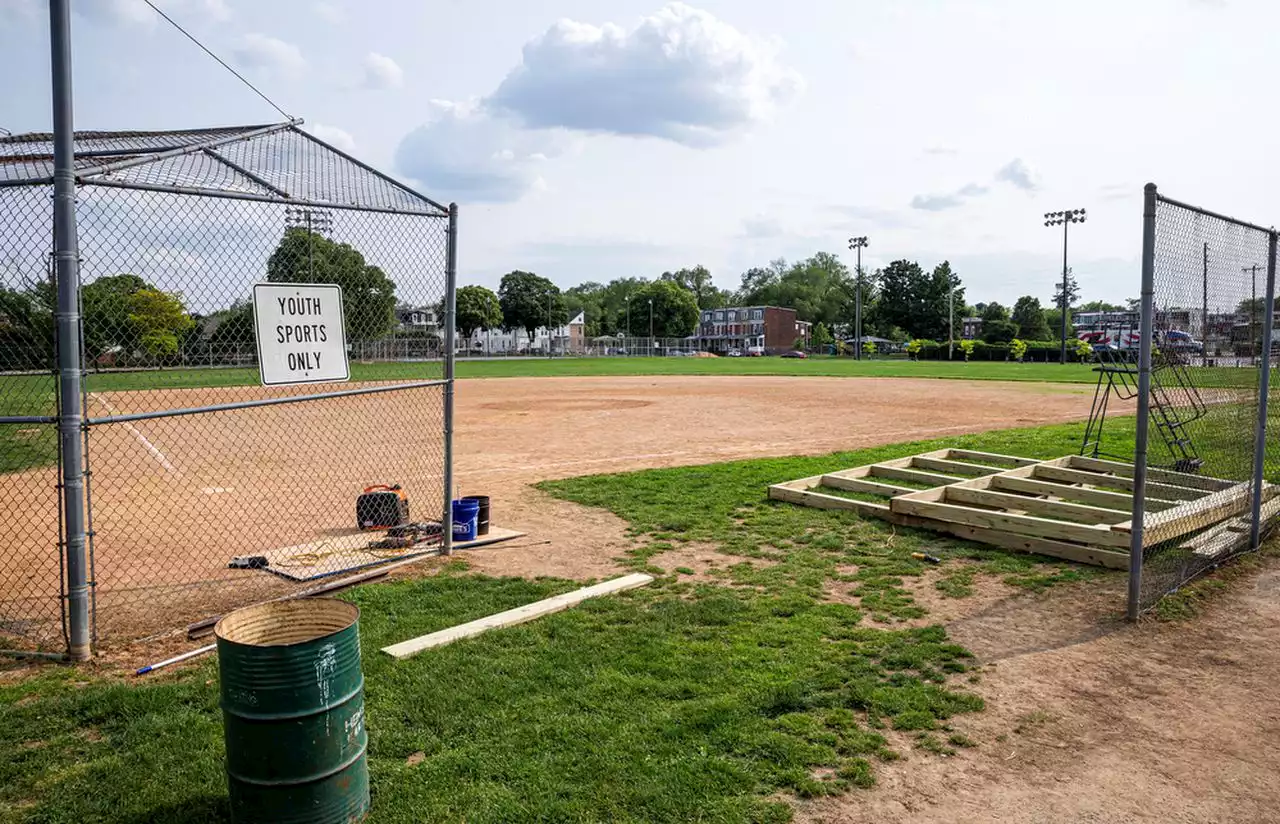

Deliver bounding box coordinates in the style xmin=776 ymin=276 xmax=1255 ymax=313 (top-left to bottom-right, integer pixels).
xmin=0 ymin=118 xmax=457 ymax=659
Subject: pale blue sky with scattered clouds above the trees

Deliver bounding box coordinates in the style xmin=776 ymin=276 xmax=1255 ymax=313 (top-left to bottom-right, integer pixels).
xmin=0 ymin=0 xmax=1280 ymax=305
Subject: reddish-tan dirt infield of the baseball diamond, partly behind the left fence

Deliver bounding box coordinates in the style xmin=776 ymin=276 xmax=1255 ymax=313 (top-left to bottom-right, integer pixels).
xmin=0 ymin=376 xmax=1092 ymax=638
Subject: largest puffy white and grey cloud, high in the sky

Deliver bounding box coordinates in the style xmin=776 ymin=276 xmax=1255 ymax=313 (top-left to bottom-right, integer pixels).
xmin=486 ymin=3 xmax=803 ymax=146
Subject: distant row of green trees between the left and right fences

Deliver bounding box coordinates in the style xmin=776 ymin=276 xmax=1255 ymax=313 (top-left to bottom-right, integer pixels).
xmin=456 ymin=252 xmax=1134 ymax=344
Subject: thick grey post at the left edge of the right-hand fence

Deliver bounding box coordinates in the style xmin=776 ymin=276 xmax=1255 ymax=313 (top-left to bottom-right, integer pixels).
xmin=1131 ymin=183 xmax=1156 ymax=621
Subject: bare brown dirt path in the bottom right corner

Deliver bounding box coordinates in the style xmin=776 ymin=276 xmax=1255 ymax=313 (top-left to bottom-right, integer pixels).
xmin=797 ymin=560 xmax=1280 ymax=824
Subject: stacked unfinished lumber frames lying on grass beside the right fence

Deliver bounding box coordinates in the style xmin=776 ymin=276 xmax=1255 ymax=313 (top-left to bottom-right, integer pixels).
xmin=769 ymin=449 xmax=1264 ymax=569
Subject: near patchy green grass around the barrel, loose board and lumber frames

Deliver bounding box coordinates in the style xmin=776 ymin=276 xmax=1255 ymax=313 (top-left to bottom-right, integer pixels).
xmin=0 ymin=421 xmax=1132 ymax=824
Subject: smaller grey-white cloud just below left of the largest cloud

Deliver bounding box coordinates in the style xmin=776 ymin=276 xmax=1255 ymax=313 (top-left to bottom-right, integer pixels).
xmin=396 ymin=100 xmax=566 ymax=203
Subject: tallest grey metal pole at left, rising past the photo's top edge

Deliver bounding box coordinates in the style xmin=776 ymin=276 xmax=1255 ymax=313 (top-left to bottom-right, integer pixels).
xmin=49 ymin=0 xmax=91 ymax=662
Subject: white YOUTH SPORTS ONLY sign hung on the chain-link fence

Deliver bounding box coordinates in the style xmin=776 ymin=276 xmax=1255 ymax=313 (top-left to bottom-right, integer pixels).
xmin=253 ymin=283 xmax=351 ymax=386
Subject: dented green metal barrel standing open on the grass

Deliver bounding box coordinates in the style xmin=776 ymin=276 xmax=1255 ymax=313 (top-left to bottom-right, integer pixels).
xmin=214 ymin=599 xmax=369 ymax=824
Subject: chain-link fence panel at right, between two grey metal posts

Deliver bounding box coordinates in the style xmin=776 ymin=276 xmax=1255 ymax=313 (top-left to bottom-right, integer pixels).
xmin=1129 ymin=186 xmax=1280 ymax=617
